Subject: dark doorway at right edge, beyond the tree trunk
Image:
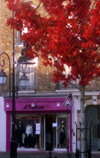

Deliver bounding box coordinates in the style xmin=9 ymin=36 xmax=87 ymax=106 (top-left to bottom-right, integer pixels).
xmin=86 ymin=105 xmax=99 ymax=151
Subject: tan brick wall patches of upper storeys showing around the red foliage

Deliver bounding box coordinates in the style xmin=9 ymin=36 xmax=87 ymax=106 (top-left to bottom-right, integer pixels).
xmin=0 ymin=0 xmax=100 ymax=94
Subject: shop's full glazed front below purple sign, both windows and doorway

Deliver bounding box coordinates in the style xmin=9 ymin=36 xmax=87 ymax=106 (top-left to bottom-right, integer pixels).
xmin=16 ymin=114 xmax=70 ymax=150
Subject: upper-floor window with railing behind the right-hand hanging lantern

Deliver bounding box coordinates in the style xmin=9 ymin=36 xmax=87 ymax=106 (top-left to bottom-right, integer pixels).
xmin=16 ymin=58 xmax=38 ymax=91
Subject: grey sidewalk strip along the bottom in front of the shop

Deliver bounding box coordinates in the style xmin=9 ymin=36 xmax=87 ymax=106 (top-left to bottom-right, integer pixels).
xmin=0 ymin=151 xmax=100 ymax=158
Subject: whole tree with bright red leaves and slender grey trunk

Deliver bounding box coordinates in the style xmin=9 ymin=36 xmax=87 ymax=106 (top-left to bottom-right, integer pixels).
xmin=6 ymin=0 xmax=100 ymax=157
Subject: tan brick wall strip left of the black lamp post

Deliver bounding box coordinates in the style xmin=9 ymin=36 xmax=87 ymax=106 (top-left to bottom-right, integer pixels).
xmin=0 ymin=0 xmax=12 ymax=91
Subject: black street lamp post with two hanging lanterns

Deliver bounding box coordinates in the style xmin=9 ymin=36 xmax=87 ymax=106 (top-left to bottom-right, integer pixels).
xmin=0 ymin=49 xmax=33 ymax=158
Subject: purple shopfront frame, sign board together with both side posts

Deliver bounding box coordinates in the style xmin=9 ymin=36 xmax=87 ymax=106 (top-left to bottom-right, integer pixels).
xmin=4 ymin=98 xmax=72 ymax=151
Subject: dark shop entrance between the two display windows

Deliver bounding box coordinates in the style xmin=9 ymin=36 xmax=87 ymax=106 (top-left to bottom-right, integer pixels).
xmin=45 ymin=114 xmax=56 ymax=150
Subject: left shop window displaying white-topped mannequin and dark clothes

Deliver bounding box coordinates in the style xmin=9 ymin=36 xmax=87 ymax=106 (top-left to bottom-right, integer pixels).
xmin=16 ymin=116 xmax=40 ymax=149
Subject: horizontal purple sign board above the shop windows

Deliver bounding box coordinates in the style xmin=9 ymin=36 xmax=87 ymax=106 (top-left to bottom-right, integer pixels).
xmin=4 ymin=97 xmax=72 ymax=112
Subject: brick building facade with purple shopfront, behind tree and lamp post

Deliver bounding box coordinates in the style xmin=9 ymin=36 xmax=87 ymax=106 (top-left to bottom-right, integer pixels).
xmin=0 ymin=0 xmax=100 ymax=152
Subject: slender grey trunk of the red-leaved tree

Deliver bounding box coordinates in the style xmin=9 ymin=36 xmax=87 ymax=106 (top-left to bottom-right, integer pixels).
xmin=80 ymin=86 xmax=86 ymax=158
